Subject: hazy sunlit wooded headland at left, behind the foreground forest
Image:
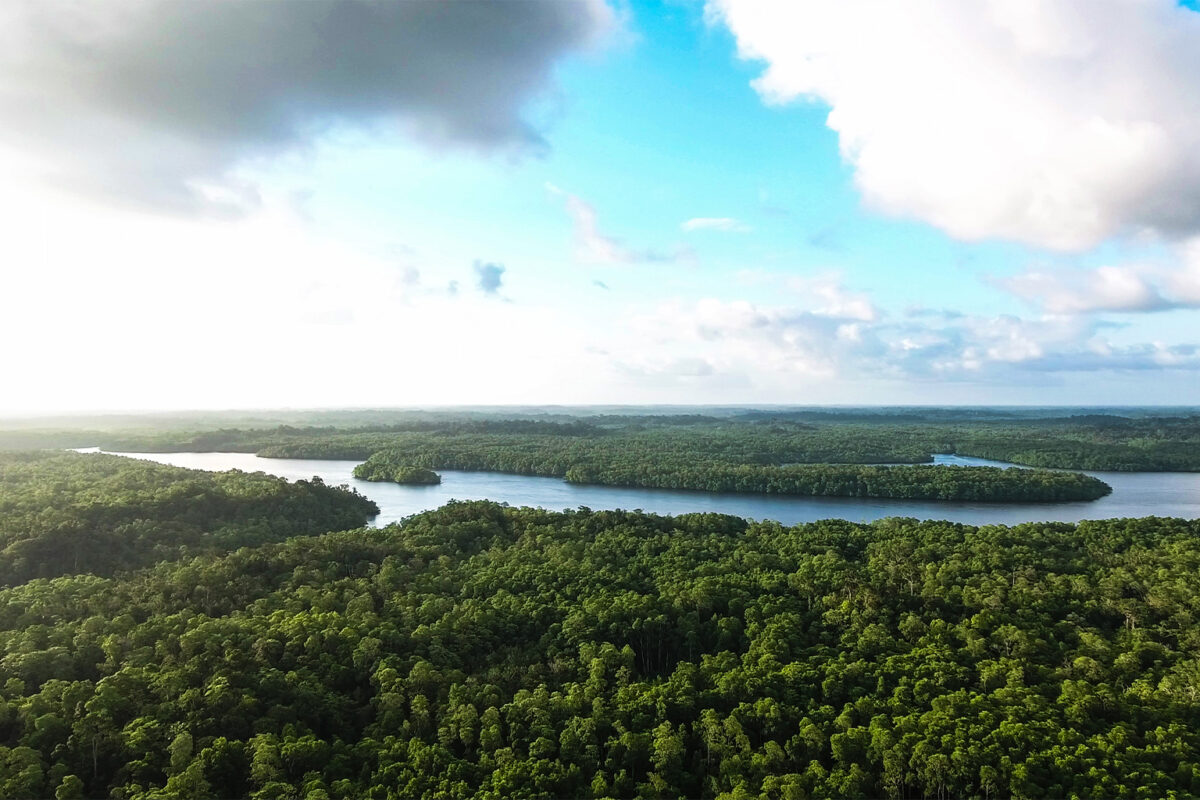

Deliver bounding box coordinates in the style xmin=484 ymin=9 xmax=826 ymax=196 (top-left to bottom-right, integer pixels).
xmin=0 ymin=452 xmax=379 ymax=587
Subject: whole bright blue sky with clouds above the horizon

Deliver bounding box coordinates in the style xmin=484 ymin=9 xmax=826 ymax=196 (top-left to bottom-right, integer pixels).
xmin=0 ymin=0 xmax=1200 ymax=414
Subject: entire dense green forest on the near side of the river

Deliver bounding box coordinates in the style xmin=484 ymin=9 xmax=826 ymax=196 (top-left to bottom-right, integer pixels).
xmin=0 ymin=453 xmax=1200 ymax=800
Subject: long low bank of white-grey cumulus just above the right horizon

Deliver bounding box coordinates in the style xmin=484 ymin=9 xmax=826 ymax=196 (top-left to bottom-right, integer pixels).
xmin=628 ymin=284 xmax=1200 ymax=384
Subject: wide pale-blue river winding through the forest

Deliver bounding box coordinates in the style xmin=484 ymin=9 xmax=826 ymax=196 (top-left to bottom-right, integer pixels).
xmin=91 ymin=452 xmax=1200 ymax=525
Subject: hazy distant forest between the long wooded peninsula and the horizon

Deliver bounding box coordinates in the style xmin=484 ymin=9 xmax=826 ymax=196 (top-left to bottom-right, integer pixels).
xmin=9 ymin=409 xmax=1200 ymax=475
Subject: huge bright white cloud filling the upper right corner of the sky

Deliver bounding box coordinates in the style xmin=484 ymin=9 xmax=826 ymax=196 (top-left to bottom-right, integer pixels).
xmin=707 ymin=0 xmax=1200 ymax=251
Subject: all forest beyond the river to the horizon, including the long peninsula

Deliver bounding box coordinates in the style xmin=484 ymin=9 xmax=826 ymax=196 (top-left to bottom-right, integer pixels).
xmin=7 ymin=409 xmax=1180 ymax=503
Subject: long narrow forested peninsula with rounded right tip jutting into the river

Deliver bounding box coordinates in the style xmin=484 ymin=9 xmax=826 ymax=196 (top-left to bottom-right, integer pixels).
xmin=354 ymin=445 xmax=1112 ymax=503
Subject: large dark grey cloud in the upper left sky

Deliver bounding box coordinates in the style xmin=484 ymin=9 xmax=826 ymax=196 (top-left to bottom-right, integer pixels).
xmin=0 ymin=0 xmax=613 ymax=210
